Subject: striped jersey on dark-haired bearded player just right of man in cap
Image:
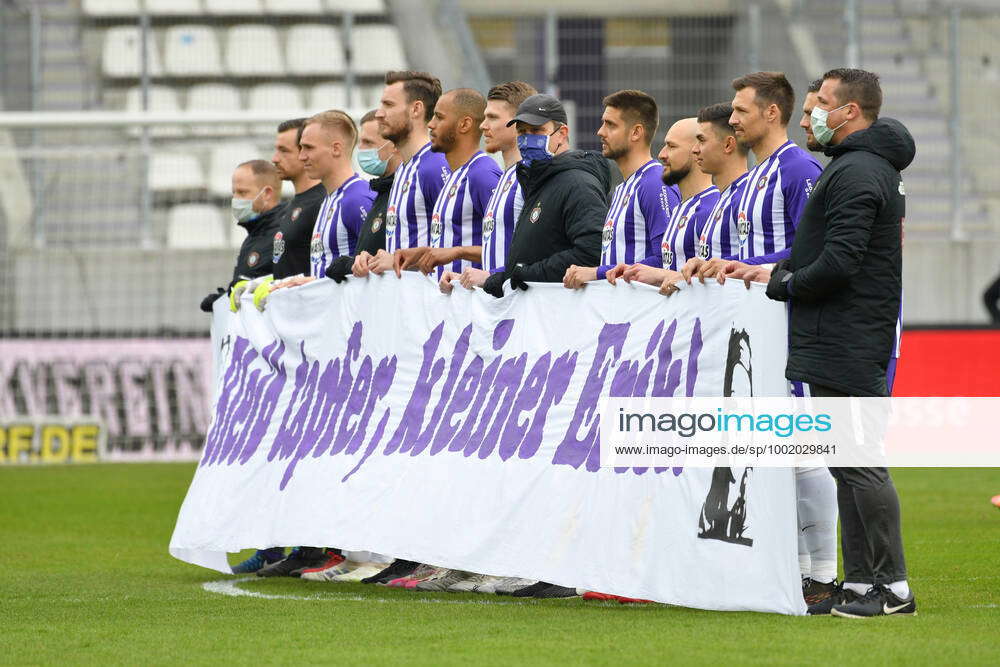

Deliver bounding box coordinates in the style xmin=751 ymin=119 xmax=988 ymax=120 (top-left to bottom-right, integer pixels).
xmin=597 ymin=160 xmax=681 ymax=280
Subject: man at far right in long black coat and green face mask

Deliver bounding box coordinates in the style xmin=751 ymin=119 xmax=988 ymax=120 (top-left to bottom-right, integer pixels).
xmin=767 ymin=69 xmax=916 ymax=618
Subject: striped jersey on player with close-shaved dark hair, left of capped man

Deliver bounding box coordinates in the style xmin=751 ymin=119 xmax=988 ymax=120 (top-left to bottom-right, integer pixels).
xmin=430 ymin=151 xmax=500 ymax=277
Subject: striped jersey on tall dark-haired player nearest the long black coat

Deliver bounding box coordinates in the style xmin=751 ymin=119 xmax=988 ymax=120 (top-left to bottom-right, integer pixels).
xmin=736 ymin=141 xmax=823 ymax=264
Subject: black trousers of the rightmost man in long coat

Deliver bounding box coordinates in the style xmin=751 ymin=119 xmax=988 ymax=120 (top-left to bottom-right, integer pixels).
xmin=809 ymin=384 xmax=906 ymax=585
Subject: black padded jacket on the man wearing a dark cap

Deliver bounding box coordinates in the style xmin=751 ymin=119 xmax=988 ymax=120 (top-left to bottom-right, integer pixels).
xmin=484 ymin=151 xmax=611 ymax=294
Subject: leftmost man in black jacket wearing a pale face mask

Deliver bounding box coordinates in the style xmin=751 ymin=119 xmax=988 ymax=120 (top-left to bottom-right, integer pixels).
xmin=201 ymin=160 xmax=283 ymax=313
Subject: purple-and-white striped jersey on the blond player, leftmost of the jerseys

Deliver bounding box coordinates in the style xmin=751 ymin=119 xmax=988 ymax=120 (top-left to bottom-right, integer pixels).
xmin=309 ymin=174 xmax=375 ymax=278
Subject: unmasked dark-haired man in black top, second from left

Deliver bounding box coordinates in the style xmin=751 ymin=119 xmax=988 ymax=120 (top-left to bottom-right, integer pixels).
xmin=271 ymin=118 xmax=326 ymax=280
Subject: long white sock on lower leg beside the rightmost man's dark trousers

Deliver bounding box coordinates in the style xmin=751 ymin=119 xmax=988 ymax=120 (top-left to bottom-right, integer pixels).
xmin=795 ymin=468 xmax=838 ymax=584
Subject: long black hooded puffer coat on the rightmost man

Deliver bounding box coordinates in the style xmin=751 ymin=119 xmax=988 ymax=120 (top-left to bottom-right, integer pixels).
xmin=785 ymin=118 xmax=916 ymax=396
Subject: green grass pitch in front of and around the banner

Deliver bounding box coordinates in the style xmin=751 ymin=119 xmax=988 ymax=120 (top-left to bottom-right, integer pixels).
xmin=0 ymin=464 xmax=1000 ymax=665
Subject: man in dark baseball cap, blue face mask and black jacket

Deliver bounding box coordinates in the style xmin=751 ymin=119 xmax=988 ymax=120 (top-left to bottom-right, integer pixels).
xmin=483 ymin=95 xmax=611 ymax=297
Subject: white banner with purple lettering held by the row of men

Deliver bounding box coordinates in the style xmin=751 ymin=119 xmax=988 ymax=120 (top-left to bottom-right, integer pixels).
xmin=170 ymin=273 xmax=805 ymax=614
